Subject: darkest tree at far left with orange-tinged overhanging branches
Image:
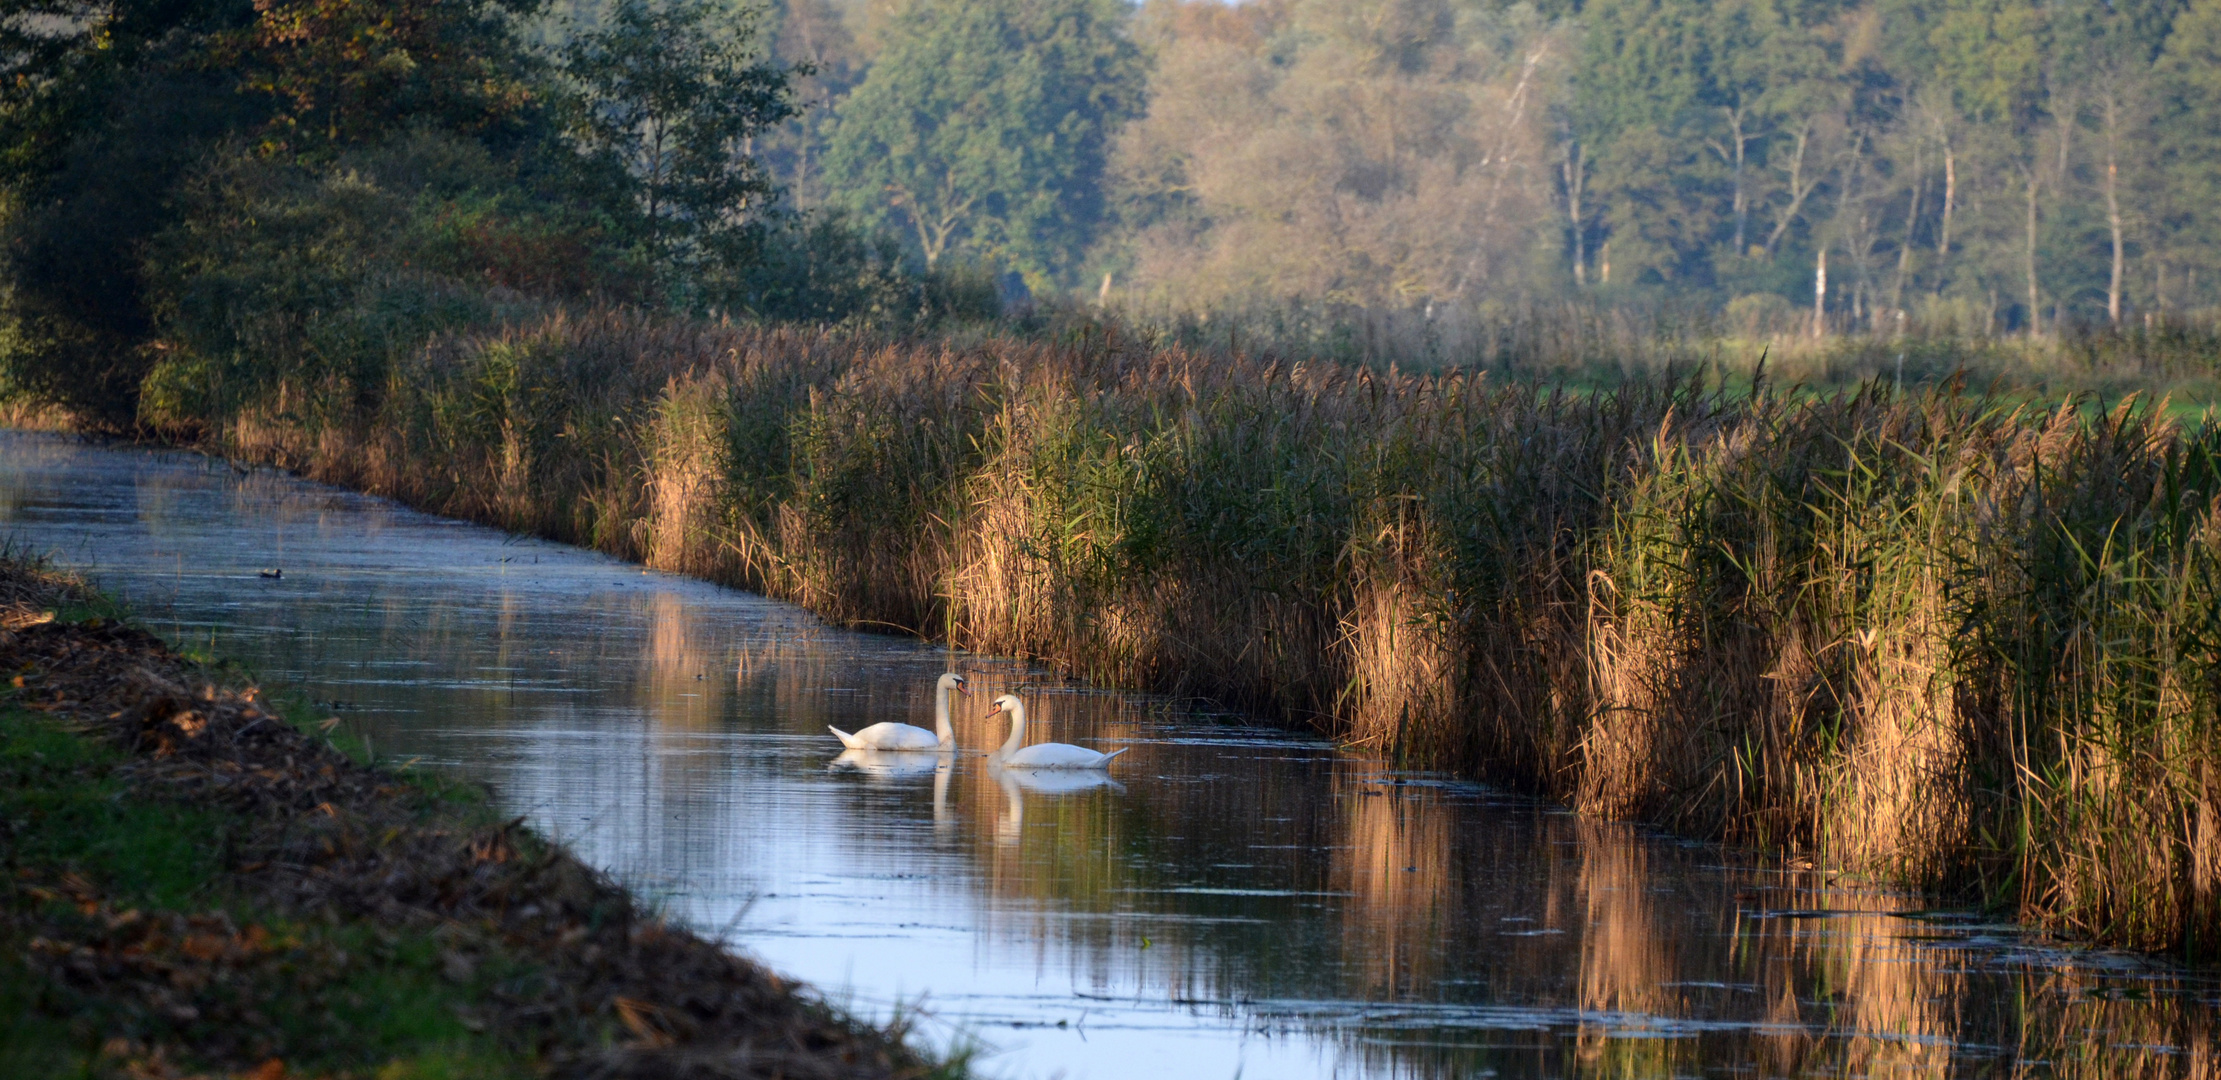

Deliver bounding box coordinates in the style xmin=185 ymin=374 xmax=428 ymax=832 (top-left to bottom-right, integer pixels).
xmin=0 ymin=0 xmax=564 ymax=427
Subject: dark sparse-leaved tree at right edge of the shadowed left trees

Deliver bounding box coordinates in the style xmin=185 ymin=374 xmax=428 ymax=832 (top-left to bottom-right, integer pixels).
xmin=562 ymin=0 xmax=795 ymax=273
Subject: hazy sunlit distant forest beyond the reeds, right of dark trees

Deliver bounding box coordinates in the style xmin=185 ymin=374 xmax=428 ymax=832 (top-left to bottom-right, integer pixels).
xmin=760 ymin=0 xmax=2221 ymax=333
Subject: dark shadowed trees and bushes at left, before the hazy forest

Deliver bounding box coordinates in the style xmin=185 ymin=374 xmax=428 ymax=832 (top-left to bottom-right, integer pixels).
xmin=0 ymin=0 xmax=962 ymax=429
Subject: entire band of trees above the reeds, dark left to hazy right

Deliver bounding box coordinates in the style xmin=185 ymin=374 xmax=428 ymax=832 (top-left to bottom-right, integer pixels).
xmin=17 ymin=0 xmax=2221 ymax=435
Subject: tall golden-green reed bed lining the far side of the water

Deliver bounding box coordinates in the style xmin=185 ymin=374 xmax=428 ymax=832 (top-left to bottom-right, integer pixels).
xmin=202 ymin=311 xmax=2221 ymax=956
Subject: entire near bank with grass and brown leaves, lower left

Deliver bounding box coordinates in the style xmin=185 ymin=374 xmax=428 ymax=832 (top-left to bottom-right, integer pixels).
xmin=0 ymin=562 xmax=959 ymax=1080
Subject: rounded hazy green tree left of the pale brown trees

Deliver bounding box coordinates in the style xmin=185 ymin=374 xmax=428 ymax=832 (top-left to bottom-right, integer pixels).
xmin=826 ymin=0 xmax=1144 ymax=287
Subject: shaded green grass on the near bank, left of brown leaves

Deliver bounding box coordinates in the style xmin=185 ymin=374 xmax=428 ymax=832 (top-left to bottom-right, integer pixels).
xmin=0 ymin=707 xmax=531 ymax=1078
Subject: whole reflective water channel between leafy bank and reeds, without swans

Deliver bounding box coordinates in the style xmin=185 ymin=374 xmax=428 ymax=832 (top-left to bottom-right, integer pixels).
xmin=0 ymin=433 xmax=2221 ymax=1080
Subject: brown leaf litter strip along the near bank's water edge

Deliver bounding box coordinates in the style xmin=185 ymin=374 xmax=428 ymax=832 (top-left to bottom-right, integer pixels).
xmin=0 ymin=560 xmax=931 ymax=1080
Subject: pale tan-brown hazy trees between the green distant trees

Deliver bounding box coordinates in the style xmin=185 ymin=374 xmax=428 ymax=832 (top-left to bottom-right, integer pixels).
xmin=1097 ymin=0 xmax=1572 ymax=318
